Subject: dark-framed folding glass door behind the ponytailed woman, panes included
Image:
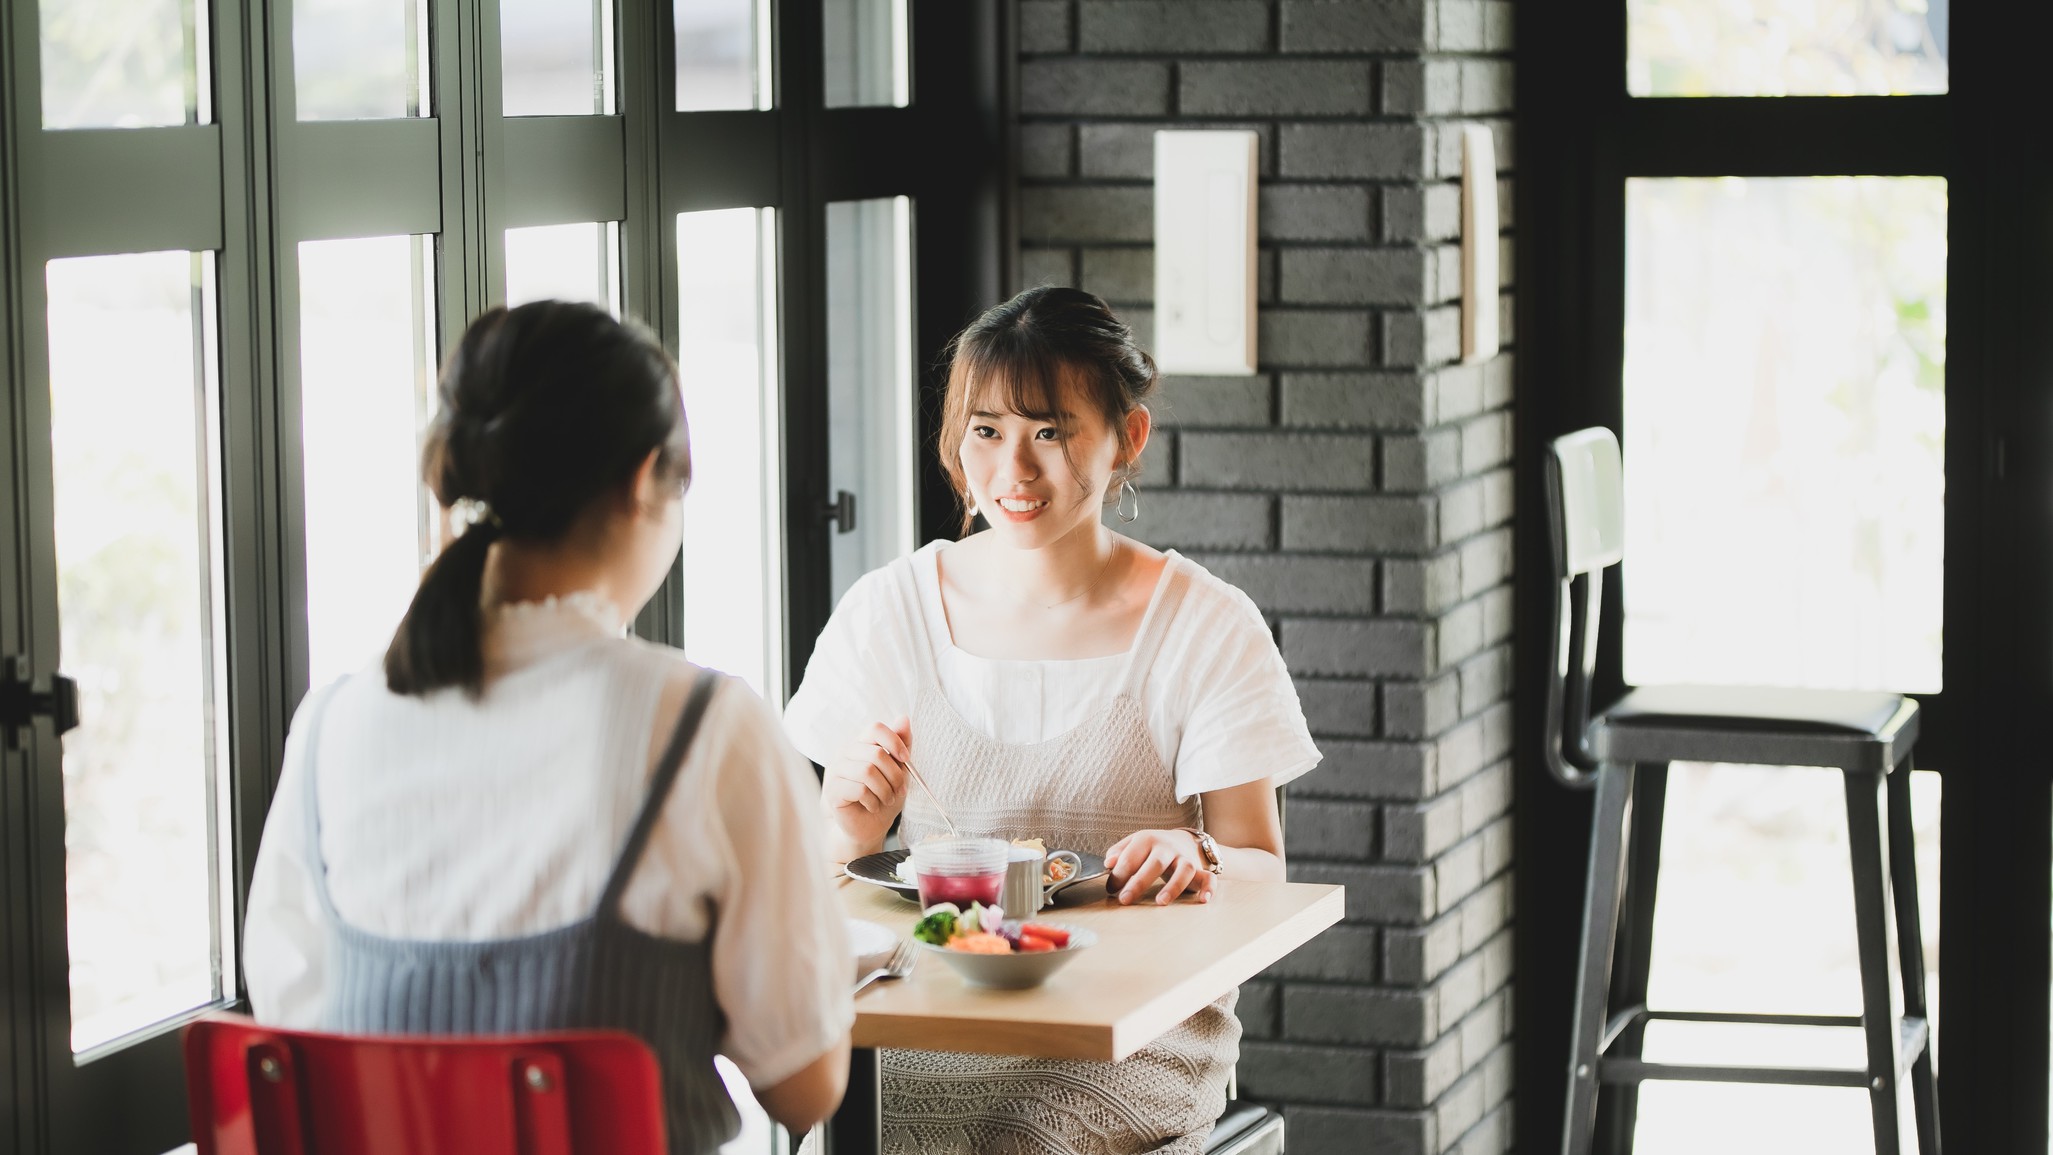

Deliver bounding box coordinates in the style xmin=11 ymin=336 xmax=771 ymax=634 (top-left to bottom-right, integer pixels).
xmin=0 ymin=0 xmax=1000 ymax=1155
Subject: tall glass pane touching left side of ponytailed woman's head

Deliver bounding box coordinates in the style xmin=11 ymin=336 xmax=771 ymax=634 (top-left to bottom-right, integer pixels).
xmin=300 ymin=236 xmax=439 ymax=685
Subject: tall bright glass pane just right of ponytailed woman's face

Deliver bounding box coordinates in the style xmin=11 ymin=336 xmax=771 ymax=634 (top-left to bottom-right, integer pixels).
xmin=677 ymin=209 xmax=784 ymax=702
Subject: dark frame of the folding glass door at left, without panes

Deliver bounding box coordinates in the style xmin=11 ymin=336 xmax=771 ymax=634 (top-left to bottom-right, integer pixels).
xmin=0 ymin=0 xmax=1010 ymax=1155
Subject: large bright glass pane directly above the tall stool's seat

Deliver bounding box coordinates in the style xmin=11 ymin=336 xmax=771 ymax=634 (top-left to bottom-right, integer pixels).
xmin=1624 ymin=176 xmax=1946 ymax=691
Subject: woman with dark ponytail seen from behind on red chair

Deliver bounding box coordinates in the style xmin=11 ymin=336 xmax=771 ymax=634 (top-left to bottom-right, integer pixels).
xmin=242 ymin=302 xmax=854 ymax=1155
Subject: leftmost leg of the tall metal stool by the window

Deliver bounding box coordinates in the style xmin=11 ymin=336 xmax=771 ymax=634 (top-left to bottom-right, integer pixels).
xmin=1562 ymin=763 xmax=1634 ymax=1155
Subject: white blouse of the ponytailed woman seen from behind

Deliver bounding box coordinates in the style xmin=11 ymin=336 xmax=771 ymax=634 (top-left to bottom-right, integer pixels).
xmin=242 ymin=595 xmax=854 ymax=1087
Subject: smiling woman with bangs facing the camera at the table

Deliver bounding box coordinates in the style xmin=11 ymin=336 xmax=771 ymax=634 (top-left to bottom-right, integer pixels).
xmin=784 ymin=289 xmax=1318 ymax=1155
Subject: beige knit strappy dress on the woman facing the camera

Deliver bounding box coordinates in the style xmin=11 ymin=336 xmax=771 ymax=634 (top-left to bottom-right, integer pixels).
xmin=883 ymin=556 xmax=1240 ymax=1155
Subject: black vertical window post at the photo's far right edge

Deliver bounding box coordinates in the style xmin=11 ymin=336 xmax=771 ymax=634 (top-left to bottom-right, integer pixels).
xmin=1920 ymin=4 xmax=2053 ymax=1151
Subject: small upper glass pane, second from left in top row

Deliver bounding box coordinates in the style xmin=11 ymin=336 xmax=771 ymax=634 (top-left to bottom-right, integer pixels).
xmin=292 ymin=0 xmax=429 ymax=121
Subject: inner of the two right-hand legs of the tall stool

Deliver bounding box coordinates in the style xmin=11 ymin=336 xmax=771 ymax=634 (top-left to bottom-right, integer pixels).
xmin=1846 ymin=771 xmax=1903 ymax=1155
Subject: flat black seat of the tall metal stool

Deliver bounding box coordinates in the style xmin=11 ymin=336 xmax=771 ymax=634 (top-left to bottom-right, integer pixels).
xmin=1589 ymin=685 xmax=1918 ymax=771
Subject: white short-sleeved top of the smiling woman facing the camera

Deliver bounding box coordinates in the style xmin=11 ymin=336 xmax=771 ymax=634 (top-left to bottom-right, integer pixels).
xmin=784 ymin=542 xmax=1320 ymax=802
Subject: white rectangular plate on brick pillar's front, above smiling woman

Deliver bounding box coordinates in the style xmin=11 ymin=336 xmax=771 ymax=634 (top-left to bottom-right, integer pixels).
xmin=1154 ymin=131 xmax=1261 ymax=377
